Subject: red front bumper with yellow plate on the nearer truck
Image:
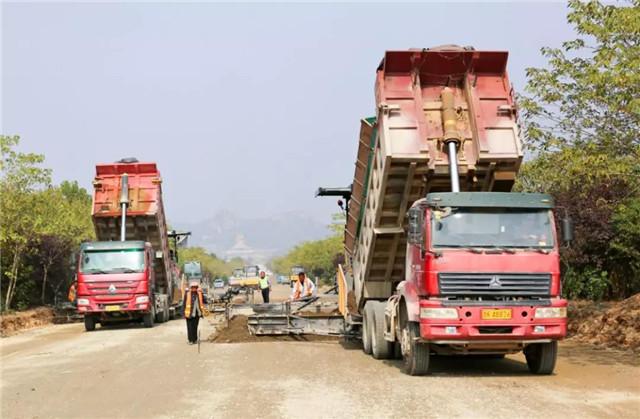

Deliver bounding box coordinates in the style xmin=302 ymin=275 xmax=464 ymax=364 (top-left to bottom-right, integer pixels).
xmin=420 ymin=299 xmax=567 ymax=345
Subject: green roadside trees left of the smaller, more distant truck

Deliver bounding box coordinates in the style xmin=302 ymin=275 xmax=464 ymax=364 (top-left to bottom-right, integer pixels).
xmin=0 ymin=136 xmax=93 ymax=309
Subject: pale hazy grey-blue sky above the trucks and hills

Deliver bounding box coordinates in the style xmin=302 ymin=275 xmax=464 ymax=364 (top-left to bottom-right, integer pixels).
xmin=0 ymin=2 xmax=573 ymax=223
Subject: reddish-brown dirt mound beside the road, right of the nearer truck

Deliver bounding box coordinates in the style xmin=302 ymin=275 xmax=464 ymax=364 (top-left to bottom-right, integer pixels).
xmin=568 ymin=294 xmax=640 ymax=351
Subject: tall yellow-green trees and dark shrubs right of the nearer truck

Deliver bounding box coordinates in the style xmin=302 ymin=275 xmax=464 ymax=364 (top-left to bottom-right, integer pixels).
xmin=516 ymin=1 xmax=640 ymax=299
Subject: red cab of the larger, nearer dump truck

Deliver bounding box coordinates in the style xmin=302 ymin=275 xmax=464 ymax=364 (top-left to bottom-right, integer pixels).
xmin=398 ymin=192 xmax=567 ymax=373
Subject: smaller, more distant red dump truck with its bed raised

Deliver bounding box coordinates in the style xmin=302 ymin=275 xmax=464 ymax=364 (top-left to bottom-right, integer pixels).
xmin=77 ymin=158 xmax=183 ymax=331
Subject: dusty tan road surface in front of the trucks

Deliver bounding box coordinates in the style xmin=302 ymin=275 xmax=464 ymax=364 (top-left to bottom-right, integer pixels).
xmin=0 ymin=288 xmax=640 ymax=418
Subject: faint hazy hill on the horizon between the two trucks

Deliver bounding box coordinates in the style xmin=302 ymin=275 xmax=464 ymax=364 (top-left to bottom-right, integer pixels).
xmin=175 ymin=210 xmax=330 ymax=261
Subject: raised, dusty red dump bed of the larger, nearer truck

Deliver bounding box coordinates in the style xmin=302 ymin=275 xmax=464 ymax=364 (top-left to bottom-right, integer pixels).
xmin=345 ymin=47 xmax=522 ymax=307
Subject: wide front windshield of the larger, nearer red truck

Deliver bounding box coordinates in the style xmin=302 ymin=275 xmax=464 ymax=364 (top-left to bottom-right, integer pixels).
xmin=431 ymin=208 xmax=553 ymax=248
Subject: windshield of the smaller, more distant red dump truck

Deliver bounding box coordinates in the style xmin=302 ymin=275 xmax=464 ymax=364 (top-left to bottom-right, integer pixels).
xmin=80 ymin=249 xmax=144 ymax=274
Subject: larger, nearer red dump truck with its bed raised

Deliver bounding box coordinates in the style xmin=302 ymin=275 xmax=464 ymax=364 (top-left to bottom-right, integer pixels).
xmin=318 ymin=46 xmax=572 ymax=375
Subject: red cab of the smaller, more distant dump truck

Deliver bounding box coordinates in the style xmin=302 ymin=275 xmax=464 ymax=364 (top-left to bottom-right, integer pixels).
xmin=77 ymin=240 xmax=155 ymax=331
